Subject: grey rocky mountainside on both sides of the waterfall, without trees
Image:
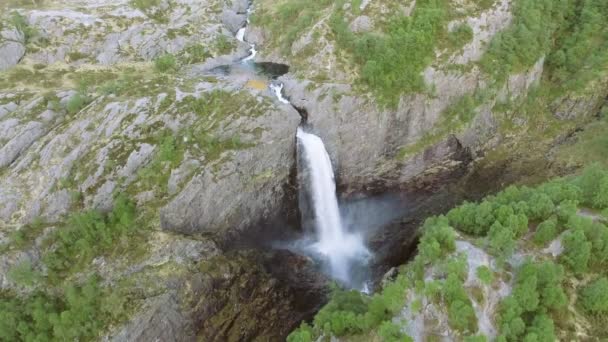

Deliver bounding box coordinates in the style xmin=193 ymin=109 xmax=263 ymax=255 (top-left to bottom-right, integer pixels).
xmin=0 ymin=0 xmax=608 ymax=341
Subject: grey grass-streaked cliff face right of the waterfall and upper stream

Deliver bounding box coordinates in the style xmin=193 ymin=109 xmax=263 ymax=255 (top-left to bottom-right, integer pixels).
xmin=250 ymin=0 xmax=607 ymax=193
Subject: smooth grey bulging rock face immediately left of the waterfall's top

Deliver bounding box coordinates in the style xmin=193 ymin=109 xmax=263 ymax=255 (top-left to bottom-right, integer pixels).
xmin=161 ymin=103 xmax=300 ymax=238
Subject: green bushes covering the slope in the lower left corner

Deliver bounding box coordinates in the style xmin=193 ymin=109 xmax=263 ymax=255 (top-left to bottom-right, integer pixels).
xmin=0 ymin=195 xmax=147 ymax=341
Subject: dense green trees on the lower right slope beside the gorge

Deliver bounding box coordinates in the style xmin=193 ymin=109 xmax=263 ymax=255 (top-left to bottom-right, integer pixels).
xmin=288 ymin=165 xmax=608 ymax=341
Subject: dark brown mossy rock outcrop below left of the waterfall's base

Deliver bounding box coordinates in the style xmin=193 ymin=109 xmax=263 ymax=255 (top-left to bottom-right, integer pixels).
xmin=105 ymin=251 xmax=327 ymax=341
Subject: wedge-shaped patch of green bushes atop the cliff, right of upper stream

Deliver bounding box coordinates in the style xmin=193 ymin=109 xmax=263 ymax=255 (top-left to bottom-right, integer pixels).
xmin=330 ymin=0 xmax=448 ymax=106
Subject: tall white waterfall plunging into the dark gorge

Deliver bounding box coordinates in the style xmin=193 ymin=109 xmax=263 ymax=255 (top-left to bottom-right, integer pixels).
xmin=297 ymin=128 xmax=370 ymax=284
